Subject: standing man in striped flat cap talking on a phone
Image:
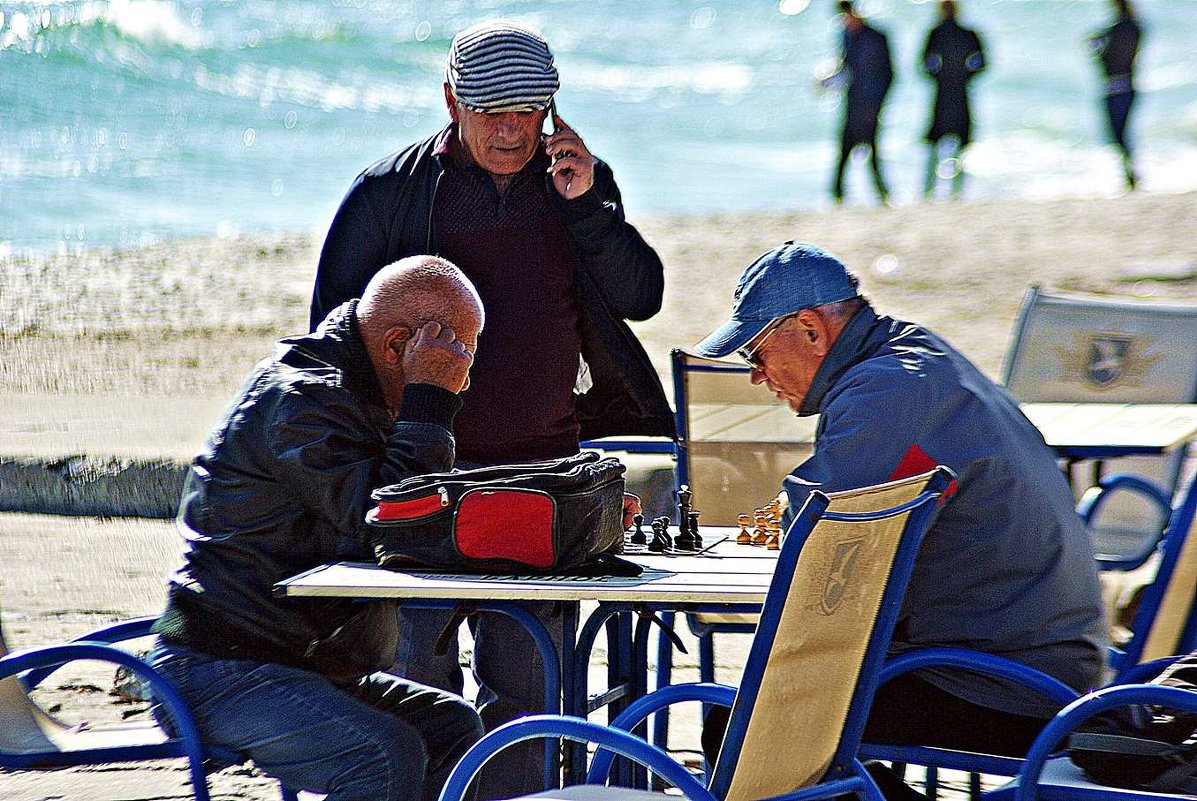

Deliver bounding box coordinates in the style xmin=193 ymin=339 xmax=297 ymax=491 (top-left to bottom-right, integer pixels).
xmin=311 ymin=22 xmax=673 ymax=799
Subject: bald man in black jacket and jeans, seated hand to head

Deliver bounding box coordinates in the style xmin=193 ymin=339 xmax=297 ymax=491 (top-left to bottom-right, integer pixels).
xmin=152 ymin=256 xmax=482 ymax=801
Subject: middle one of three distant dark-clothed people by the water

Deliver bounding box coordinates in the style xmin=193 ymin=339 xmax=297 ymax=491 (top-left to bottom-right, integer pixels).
xmin=923 ymin=0 xmax=985 ymax=198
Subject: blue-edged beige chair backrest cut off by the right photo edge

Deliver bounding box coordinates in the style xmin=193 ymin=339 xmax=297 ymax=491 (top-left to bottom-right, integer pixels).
xmin=1118 ymin=475 xmax=1197 ymax=669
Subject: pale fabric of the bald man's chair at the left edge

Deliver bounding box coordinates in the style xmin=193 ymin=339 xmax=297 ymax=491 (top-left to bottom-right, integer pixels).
xmin=0 ymin=605 xmax=166 ymax=753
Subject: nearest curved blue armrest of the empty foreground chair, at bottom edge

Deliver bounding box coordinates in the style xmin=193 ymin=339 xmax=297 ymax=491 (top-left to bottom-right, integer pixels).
xmin=440 ymin=715 xmax=715 ymax=801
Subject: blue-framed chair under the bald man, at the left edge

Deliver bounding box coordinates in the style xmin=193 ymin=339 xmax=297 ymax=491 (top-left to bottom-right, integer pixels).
xmin=0 ymin=608 xmax=298 ymax=801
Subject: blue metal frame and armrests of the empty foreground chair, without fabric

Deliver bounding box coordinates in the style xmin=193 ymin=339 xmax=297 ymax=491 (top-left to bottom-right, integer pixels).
xmin=440 ymin=468 xmax=952 ymax=801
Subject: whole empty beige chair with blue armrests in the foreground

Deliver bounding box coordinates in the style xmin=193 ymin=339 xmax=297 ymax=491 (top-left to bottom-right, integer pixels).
xmin=440 ymin=468 xmax=952 ymax=801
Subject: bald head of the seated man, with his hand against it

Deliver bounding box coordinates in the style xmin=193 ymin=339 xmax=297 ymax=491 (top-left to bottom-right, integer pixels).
xmin=357 ymin=256 xmax=484 ymax=409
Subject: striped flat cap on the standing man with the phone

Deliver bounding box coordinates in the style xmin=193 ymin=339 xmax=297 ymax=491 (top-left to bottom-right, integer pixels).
xmin=445 ymin=19 xmax=560 ymax=113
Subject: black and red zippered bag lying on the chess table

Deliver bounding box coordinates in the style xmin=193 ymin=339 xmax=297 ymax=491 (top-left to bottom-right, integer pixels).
xmin=366 ymin=451 xmax=625 ymax=574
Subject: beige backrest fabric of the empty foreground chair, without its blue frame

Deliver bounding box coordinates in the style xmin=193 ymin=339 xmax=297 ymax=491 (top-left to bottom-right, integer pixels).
xmin=708 ymin=474 xmax=930 ymax=801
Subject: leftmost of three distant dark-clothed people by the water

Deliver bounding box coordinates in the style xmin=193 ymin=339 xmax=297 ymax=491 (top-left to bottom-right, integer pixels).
xmin=822 ymin=0 xmax=894 ymax=204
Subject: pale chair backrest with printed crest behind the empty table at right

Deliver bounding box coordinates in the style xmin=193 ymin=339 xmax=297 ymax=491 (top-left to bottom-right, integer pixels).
xmin=1004 ymin=286 xmax=1197 ymax=553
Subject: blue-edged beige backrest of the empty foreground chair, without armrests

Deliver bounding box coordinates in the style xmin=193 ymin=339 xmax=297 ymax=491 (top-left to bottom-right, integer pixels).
xmin=711 ymin=468 xmax=952 ymax=801
